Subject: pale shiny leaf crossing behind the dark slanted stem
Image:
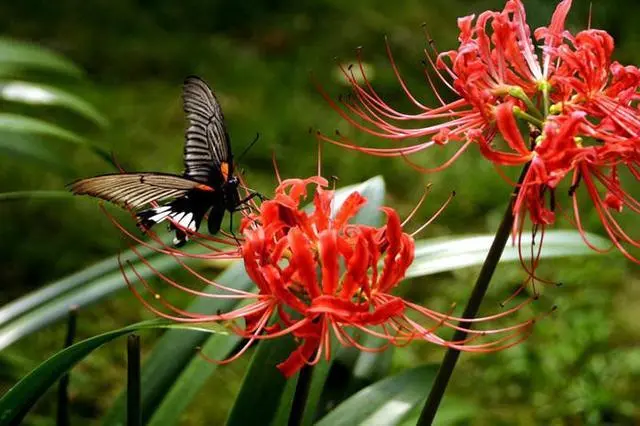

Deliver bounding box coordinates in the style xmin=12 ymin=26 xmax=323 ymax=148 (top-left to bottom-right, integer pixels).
xmin=407 ymin=231 xmax=607 ymax=278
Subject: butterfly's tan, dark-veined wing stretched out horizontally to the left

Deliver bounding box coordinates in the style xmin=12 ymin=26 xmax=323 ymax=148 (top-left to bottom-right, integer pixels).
xmin=69 ymin=173 xmax=205 ymax=209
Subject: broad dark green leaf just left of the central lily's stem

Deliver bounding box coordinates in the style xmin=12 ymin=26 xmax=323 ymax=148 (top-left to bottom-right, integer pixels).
xmin=226 ymin=336 xmax=295 ymax=426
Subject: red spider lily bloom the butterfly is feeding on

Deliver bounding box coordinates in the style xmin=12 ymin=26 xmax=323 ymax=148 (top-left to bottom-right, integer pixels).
xmin=115 ymin=172 xmax=534 ymax=377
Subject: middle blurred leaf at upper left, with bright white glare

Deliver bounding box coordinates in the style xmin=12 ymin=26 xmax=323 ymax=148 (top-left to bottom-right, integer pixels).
xmin=0 ymin=81 xmax=107 ymax=127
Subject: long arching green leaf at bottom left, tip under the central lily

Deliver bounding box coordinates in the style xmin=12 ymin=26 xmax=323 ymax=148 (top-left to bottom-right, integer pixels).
xmin=0 ymin=320 xmax=226 ymax=425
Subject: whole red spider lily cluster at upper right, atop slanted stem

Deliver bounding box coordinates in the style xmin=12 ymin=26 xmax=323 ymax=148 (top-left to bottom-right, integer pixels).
xmin=319 ymin=0 xmax=640 ymax=263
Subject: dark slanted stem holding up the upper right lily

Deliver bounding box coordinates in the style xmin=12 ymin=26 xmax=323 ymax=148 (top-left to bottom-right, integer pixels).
xmin=417 ymin=163 xmax=529 ymax=426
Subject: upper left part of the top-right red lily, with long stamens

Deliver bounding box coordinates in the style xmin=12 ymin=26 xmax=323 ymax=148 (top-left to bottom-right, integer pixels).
xmin=319 ymin=0 xmax=571 ymax=172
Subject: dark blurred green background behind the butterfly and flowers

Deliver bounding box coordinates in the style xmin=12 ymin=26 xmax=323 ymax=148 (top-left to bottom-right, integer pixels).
xmin=0 ymin=0 xmax=640 ymax=425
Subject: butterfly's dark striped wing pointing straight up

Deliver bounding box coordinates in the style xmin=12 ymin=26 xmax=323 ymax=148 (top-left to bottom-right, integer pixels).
xmin=182 ymin=76 xmax=233 ymax=188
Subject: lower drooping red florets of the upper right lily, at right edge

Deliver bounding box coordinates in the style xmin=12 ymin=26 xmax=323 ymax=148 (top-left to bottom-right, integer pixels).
xmin=480 ymin=104 xmax=640 ymax=263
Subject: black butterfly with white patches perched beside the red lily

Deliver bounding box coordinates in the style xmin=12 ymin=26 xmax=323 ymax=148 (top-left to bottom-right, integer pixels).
xmin=70 ymin=76 xmax=250 ymax=246
